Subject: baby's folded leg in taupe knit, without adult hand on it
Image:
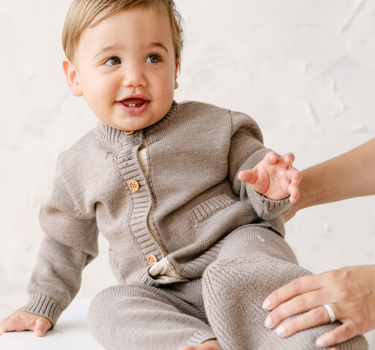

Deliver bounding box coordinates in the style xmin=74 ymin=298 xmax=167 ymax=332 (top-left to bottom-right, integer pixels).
xmin=88 ymin=282 xmax=215 ymax=350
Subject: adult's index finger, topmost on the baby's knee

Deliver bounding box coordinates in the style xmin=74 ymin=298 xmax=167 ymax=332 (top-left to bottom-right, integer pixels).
xmin=262 ymin=275 xmax=323 ymax=311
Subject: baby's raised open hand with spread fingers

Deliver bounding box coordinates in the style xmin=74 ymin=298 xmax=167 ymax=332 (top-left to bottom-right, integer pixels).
xmin=238 ymin=152 xmax=302 ymax=203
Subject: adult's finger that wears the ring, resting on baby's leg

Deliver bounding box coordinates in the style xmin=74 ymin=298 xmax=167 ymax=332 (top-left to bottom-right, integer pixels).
xmin=276 ymin=306 xmax=330 ymax=338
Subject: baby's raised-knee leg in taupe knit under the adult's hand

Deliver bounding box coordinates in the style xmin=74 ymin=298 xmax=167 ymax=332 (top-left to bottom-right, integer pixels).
xmin=203 ymin=226 xmax=368 ymax=350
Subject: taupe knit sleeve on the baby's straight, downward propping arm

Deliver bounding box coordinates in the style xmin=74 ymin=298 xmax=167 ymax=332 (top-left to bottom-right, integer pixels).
xmin=19 ymin=160 xmax=98 ymax=326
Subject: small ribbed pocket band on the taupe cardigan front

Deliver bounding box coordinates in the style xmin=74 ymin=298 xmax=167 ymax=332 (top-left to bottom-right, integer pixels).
xmin=189 ymin=194 xmax=235 ymax=227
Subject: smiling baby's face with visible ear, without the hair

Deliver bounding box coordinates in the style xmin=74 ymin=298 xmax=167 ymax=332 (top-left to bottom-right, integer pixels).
xmin=63 ymin=9 xmax=178 ymax=130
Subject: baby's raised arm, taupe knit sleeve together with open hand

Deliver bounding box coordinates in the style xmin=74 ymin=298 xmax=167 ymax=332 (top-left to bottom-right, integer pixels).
xmin=228 ymin=111 xmax=299 ymax=221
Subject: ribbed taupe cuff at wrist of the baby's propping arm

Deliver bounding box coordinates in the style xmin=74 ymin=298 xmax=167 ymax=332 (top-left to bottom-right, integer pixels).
xmin=18 ymin=294 xmax=63 ymax=328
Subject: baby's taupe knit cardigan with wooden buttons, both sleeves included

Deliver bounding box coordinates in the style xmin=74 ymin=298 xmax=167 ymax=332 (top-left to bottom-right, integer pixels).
xmin=20 ymin=101 xmax=290 ymax=325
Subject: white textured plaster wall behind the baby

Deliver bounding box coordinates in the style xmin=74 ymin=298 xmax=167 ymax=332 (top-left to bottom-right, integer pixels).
xmin=0 ymin=0 xmax=375 ymax=344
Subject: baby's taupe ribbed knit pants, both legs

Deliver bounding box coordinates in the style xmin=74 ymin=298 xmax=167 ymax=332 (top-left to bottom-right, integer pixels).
xmin=88 ymin=225 xmax=368 ymax=350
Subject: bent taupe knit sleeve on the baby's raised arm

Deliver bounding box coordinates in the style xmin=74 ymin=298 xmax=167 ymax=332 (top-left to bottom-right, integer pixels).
xmin=228 ymin=111 xmax=291 ymax=220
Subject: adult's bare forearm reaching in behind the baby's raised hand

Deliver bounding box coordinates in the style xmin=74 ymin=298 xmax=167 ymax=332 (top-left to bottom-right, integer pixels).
xmin=284 ymin=139 xmax=375 ymax=221
